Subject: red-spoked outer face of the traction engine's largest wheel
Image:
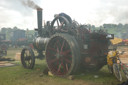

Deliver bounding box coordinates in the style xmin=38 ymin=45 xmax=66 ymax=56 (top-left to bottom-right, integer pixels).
xmin=46 ymin=37 xmax=73 ymax=76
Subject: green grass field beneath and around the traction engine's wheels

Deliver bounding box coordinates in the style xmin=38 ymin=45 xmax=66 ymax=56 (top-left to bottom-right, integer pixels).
xmin=0 ymin=48 xmax=125 ymax=85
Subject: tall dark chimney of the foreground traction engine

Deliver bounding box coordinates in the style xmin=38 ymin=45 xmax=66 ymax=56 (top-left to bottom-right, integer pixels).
xmin=37 ymin=8 xmax=42 ymax=36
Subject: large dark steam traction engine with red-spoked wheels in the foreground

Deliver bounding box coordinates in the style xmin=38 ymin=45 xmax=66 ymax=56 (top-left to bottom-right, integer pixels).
xmin=21 ymin=9 xmax=111 ymax=76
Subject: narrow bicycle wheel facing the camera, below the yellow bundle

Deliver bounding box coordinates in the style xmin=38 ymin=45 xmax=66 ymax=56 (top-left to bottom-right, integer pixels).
xmin=113 ymin=63 xmax=122 ymax=81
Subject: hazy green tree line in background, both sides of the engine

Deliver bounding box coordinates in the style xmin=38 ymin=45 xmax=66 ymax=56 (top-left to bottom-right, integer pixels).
xmin=0 ymin=23 xmax=128 ymax=40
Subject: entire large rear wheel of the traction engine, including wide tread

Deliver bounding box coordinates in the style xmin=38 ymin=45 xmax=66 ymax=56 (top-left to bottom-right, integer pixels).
xmin=46 ymin=34 xmax=80 ymax=76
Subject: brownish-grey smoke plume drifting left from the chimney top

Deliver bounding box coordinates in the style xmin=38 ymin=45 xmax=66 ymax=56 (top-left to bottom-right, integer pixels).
xmin=21 ymin=0 xmax=42 ymax=9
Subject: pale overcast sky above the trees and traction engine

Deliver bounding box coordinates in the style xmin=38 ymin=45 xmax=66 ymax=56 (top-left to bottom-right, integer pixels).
xmin=0 ymin=0 xmax=128 ymax=29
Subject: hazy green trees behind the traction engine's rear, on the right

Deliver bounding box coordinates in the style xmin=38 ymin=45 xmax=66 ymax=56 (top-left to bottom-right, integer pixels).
xmin=88 ymin=23 xmax=128 ymax=39
